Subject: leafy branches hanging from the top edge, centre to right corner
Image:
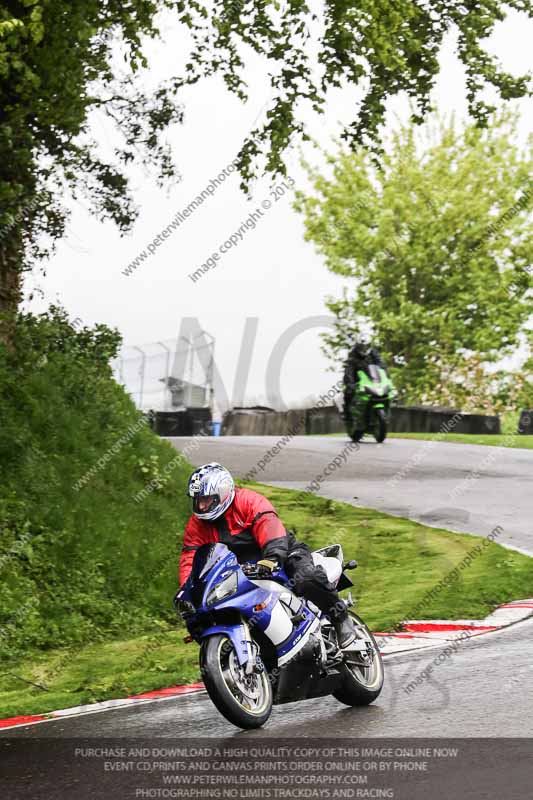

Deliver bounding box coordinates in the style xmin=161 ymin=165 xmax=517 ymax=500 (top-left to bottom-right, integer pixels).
xmin=177 ymin=0 xmax=533 ymax=183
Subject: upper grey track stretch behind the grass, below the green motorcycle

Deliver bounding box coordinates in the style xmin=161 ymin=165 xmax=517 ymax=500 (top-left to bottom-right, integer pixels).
xmin=169 ymin=436 xmax=533 ymax=555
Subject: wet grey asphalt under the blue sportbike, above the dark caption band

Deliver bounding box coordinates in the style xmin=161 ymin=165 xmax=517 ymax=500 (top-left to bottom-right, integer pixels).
xmin=4 ymin=619 xmax=533 ymax=741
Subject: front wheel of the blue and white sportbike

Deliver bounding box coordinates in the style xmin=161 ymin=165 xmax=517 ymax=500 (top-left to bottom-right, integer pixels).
xmin=200 ymin=634 xmax=273 ymax=728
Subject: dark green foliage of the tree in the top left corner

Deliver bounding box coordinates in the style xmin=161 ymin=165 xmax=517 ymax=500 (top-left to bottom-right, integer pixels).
xmin=0 ymin=0 xmax=182 ymax=310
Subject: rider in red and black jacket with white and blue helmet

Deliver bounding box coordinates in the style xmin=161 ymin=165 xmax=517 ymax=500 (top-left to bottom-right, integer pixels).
xmin=180 ymin=462 xmax=355 ymax=648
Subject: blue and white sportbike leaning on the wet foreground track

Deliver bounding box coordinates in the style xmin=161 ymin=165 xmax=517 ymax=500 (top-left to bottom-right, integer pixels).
xmin=176 ymin=543 xmax=383 ymax=728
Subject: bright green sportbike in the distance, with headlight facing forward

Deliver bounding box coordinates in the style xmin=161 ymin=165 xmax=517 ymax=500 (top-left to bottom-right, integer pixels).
xmin=344 ymin=364 xmax=396 ymax=443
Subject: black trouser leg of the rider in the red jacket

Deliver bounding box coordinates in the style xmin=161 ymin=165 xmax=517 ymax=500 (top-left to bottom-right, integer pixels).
xmin=285 ymin=542 xmax=348 ymax=621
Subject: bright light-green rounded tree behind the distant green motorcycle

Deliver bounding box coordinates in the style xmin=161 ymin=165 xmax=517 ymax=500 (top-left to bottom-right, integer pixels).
xmin=297 ymin=115 xmax=533 ymax=408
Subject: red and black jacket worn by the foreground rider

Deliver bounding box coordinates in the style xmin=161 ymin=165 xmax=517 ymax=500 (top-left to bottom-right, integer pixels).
xmin=180 ymin=489 xmax=296 ymax=586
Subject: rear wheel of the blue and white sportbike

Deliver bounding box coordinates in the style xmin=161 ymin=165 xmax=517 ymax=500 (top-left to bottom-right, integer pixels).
xmin=333 ymin=614 xmax=384 ymax=706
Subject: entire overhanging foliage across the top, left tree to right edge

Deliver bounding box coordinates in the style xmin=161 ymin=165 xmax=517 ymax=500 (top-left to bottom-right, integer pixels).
xmin=0 ymin=0 xmax=533 ymax=314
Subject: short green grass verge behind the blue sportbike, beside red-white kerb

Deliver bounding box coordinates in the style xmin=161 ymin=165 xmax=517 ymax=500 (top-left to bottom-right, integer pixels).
xmin=0 ymin=484 xmax=533 ymax=717
